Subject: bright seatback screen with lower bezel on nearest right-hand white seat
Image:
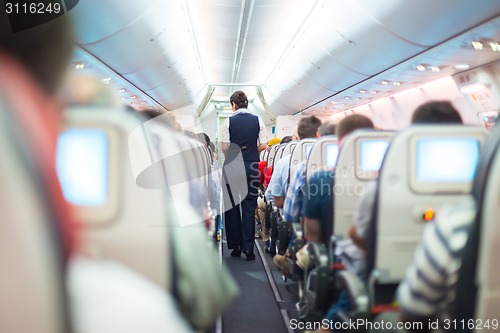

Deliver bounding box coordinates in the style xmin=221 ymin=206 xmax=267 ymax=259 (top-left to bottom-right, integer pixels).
xmin=411 ymin=138 xmax=480 ymax=193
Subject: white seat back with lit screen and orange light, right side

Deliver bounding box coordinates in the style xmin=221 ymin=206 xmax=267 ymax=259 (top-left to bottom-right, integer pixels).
xmin=367 ymin=125 xmax=487 ymax=304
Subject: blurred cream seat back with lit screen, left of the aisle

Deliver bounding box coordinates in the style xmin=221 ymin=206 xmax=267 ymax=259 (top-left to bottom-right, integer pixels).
xmin=57 ymin=107 xmax=174 ymax=290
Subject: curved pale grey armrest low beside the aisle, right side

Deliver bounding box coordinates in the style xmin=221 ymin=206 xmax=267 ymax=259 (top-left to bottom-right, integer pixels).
xmin=335 ymin=270 xmax=369 ymax=314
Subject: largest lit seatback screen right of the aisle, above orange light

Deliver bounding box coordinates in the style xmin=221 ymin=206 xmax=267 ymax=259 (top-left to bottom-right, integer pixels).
xmin=415 ymin=138 xmax=480 ymax=183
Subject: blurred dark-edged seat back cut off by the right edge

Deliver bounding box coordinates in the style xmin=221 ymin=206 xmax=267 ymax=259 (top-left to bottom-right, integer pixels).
xmin=452 ymin=126 xmax=500 ymax=326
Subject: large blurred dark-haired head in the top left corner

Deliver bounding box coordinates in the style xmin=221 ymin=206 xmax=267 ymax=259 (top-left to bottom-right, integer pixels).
xmin=0 ymin=14 xmax=74 ymax=96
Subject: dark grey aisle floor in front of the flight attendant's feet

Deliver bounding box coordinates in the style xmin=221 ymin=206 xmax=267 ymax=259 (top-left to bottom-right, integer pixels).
xmin=222 ymin=239 xmax=288 ymax=333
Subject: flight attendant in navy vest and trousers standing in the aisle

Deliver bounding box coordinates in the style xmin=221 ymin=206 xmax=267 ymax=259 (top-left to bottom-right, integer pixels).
xmin=221 ymin=91 xmax=267 ymax=260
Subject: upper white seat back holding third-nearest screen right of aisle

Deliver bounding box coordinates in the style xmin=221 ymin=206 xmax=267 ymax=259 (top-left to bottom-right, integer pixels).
xmin=306 ymin=136 xmax=339 ymax=179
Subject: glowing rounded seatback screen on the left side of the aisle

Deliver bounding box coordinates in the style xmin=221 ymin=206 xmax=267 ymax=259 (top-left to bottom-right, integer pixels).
xmin=56 ymin=128 xmax=109 ymax=206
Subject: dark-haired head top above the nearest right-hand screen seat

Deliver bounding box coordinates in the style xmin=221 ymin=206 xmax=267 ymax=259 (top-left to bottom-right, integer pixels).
xmin=411 ymin=101 xmax=463 ymax=124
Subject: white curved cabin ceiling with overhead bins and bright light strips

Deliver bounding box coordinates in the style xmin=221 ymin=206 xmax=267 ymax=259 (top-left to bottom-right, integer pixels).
xmin=71 ymin=0 xmax=500 ymax=121
